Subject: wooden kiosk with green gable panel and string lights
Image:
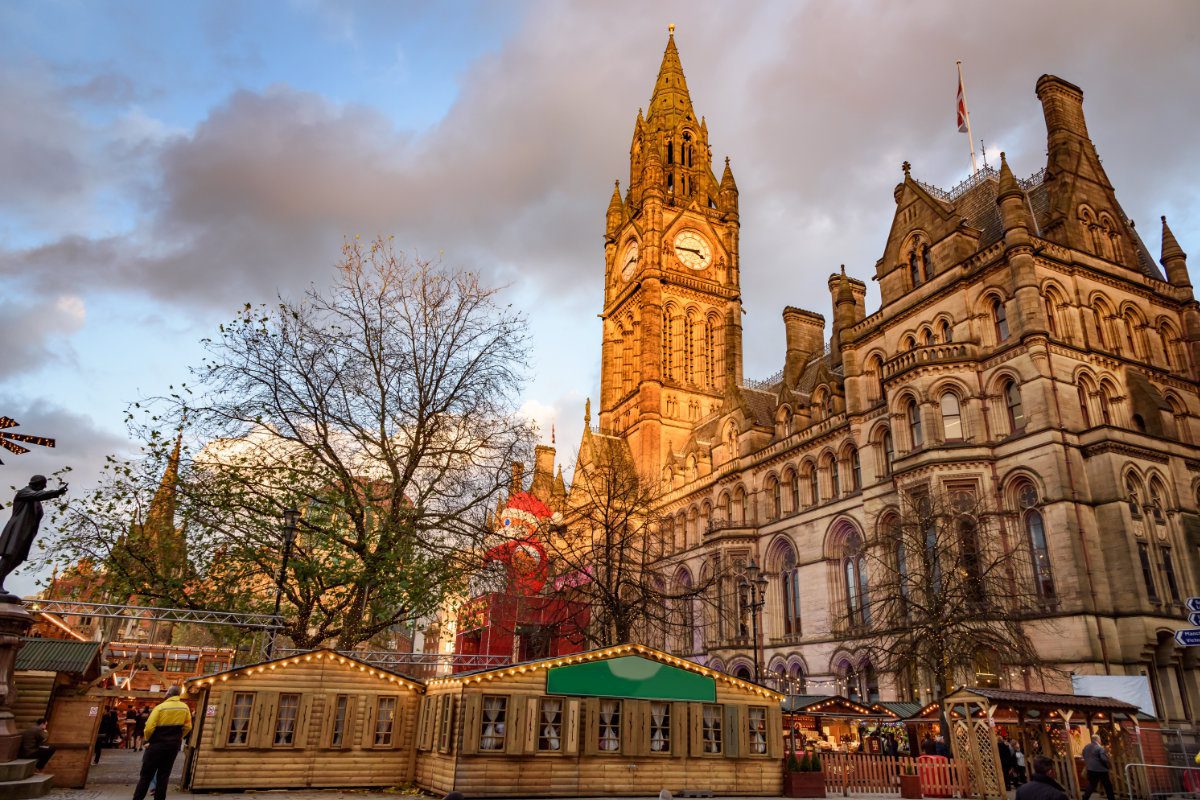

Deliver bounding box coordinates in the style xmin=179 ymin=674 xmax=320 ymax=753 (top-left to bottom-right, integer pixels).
xmin=415 ymin=644 xmax=784 ymax=798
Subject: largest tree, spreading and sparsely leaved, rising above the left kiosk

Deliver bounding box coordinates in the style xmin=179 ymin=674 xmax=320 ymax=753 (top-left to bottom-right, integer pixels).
xmin=49 ymin=239 xmax=532 ymax=648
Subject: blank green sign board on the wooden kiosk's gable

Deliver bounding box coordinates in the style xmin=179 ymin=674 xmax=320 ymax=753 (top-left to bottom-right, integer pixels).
xmin=546 ymin=656 xmax=716 ymax=703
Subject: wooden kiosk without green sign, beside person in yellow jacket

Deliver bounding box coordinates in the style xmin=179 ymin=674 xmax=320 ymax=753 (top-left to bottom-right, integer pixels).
xmin=177 ymin=650 xmax=424 ymax=790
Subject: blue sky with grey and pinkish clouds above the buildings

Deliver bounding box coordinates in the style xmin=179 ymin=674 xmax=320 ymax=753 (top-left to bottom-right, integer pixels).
xmin=0 ymin=0 xmax=1200 ymax=599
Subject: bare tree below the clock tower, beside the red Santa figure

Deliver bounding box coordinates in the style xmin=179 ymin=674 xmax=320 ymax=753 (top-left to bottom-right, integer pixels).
xmin=535 ymin=433 xmax=719 ymax=648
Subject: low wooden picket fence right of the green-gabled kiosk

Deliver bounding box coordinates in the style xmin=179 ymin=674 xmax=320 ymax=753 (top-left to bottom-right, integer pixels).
xmin=821 ymin=753 xmax=971 ymax=798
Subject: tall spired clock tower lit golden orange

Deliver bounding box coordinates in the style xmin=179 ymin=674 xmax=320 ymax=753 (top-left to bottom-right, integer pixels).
xmin=600 ymin=25 xmax=742 ymax=475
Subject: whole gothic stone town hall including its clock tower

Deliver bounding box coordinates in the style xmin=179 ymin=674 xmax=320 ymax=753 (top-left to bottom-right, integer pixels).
xmin=584 ymin=29 xmax=1200 ymax=724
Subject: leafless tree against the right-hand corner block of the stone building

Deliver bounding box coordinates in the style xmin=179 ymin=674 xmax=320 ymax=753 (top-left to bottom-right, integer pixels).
xmin=864 ymin=491 xmax=1046 ymax=696
